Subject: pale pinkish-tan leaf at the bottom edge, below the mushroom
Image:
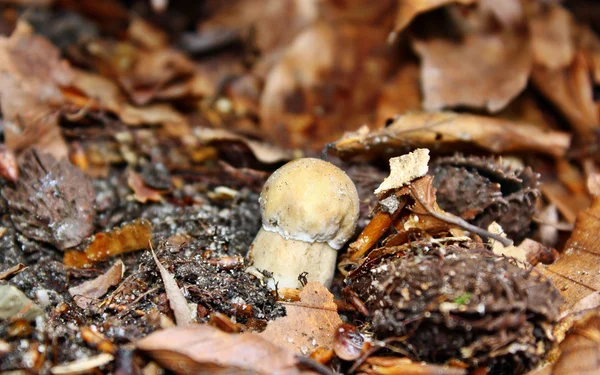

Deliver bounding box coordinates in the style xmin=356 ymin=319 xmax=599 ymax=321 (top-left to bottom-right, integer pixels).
xmin=136 ymin=324 xmax=314 ymax=375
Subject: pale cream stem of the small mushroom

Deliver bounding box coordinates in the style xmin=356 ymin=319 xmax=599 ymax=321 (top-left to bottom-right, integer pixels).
xmin=249 ymin=228 xmax=337 ymax=289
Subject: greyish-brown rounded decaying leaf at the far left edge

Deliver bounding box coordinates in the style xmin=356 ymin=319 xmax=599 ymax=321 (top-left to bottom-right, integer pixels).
xmin=2 ymin=151 xmax=96 ymax=250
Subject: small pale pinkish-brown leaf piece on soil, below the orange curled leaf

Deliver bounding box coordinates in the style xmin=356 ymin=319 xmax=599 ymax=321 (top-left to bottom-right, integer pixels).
xmin=69 ymin=260 xmax=125 ymax=309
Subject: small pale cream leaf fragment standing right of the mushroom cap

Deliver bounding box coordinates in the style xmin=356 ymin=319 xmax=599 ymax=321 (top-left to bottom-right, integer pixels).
xmin=375 ymin=148 xmax=429 ymax=195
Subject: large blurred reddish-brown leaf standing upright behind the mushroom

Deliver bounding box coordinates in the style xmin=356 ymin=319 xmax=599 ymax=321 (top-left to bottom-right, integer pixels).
xmin=260 ymin=22 xmax=391 ymax=148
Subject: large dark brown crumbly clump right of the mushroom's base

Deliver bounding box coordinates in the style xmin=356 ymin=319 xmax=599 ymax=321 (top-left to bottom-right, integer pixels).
xmin=347 ymin=242 xmax=560 ymax=374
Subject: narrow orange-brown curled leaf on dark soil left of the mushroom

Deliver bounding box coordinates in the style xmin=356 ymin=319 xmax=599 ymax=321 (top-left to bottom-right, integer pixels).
xmin=63 ymin=220 xmax=152 ymax=268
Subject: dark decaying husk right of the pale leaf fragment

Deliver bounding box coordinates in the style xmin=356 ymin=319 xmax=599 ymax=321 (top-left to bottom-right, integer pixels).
xmin=429 ymin=155 xmax=540 ymax=240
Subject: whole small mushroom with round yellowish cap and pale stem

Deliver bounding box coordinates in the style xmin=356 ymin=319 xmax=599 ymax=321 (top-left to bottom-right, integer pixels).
xmin=249 ymin=158 xmax=359 ymax=289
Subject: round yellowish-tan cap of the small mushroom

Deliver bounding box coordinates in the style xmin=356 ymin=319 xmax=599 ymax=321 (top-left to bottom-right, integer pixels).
xmin=259 ymin=158 xmax=359 ymax=250
